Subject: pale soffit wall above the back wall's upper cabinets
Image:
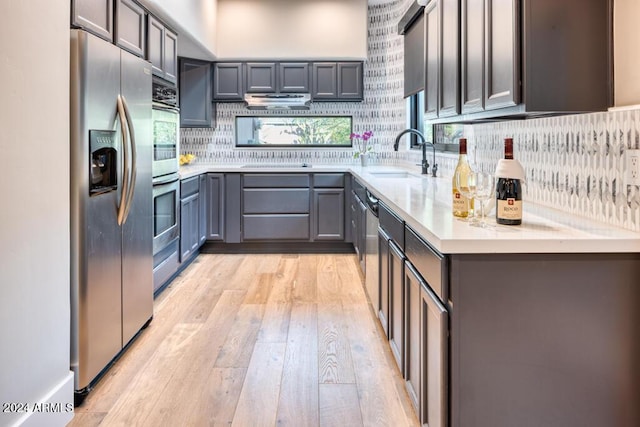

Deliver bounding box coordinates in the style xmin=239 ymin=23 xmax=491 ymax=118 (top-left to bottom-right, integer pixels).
xmin=217 ymin=0 xmax=367 ymax=60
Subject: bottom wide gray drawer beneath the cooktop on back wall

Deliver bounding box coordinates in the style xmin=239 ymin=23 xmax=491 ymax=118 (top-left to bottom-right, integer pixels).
xmin=242 ymin=214 xmax=310 ymax=241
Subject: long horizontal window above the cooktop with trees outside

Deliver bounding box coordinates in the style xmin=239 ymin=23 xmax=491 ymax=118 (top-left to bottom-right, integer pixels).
xmin=236 ymin=116 xmax=352 ymax=147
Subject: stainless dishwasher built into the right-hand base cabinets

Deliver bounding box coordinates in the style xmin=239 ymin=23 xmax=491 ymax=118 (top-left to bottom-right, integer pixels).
xmin=365 ymin=190 xmax=380 ymax=313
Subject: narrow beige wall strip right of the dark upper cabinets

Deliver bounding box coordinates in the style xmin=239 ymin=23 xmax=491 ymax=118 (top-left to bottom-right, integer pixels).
xmin=613 ymin=0 xmax=640 ymax=107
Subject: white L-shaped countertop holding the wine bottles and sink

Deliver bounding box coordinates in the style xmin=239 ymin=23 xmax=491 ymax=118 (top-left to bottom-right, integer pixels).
xmin=180 ymin=165 xmax=640 ymax=254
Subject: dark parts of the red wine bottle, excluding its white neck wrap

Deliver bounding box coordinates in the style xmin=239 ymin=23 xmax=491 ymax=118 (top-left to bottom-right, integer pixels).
xmin=496 ymin=138 xmax=522 ymax=225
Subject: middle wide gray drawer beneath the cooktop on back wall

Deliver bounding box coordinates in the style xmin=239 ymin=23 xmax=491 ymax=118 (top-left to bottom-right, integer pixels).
xmin=242 ymin=188 xmax=309 ymax=214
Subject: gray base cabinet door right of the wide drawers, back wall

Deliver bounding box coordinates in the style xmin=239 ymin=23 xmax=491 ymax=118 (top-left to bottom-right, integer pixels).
xmin=313 ymin=188 xmax=344 ymax=241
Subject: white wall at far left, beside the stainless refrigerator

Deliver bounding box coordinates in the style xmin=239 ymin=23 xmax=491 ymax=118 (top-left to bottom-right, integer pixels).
xmin=0 ymin=0 xmax=73 ymax=426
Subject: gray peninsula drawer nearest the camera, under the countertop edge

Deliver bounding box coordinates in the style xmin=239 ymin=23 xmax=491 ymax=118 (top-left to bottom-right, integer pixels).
xmin=404 ymin=227 xmax=449 ymax=301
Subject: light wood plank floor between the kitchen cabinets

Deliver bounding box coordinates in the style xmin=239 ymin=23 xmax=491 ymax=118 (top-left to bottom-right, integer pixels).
xmin=70 ymin=254 xmax=418 ymax=427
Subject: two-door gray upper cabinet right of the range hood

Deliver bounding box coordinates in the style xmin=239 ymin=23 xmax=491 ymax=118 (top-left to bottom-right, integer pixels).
xmin=311 ymin=62 xmax=363 ymax=101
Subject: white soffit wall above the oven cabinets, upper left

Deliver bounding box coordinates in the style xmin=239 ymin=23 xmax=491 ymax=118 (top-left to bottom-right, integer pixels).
xmin=140 ymin=0 xmax=218 ymax=60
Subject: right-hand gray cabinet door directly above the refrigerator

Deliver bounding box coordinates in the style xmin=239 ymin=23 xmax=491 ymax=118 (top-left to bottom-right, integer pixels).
xmin=115 ymin=0 xmax=147 ymax=58
